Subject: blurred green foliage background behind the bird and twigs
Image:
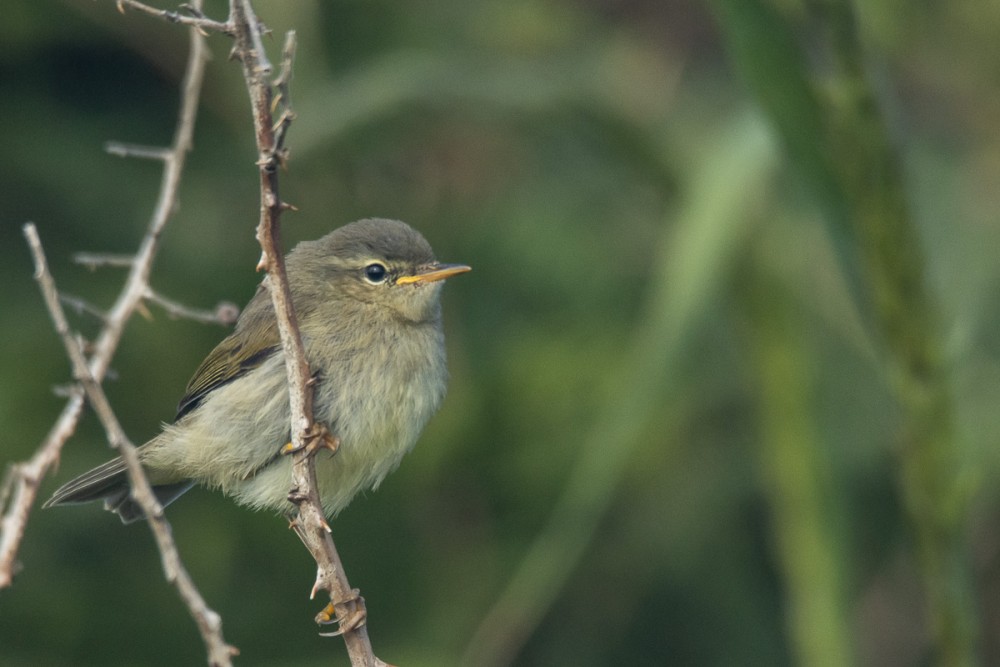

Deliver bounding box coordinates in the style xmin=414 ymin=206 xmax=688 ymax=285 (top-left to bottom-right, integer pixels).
xmin=0 ymin=0 xmax=1000 ymax=667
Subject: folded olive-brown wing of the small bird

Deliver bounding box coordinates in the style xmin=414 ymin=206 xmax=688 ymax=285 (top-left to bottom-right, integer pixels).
xmin=174 ymin=287 xmax=281 ymax=420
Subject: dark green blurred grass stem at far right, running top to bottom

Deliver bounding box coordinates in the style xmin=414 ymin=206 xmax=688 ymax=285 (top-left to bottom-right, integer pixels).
xmin=713 ymin=0 xmax=977 ymax=665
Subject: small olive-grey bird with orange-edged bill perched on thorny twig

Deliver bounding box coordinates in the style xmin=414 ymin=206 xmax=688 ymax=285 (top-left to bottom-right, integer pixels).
xmin=45 ymin=218 xmax=471 ymax=523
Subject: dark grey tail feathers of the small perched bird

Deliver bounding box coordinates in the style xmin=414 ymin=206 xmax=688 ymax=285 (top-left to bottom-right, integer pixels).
xmin=42 ymin=457 xmax=193 ymax=523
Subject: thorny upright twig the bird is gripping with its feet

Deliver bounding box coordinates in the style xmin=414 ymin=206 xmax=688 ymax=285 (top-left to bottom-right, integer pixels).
xmin=230 ymin=0 xmax=385 ymax=667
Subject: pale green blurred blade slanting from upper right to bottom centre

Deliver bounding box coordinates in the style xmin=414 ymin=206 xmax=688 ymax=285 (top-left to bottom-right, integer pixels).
xmin=463 ymin=115 xmax=776 ymax=667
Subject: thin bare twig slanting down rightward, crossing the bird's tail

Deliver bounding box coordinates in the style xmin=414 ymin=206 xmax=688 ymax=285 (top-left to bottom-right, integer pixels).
xmin=24 ymin=223 xmax=237 ymax=666
